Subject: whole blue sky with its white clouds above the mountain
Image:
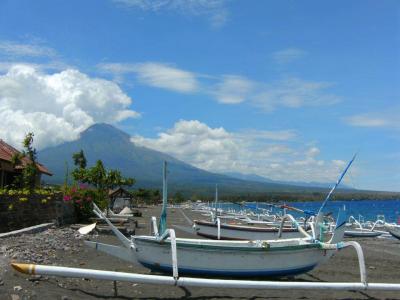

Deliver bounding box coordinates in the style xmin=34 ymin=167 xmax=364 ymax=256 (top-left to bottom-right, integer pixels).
xmin=0 ymin=0 xmax=400 ymax=191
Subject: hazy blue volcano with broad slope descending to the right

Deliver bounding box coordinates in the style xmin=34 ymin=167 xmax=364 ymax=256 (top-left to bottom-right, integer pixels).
xmin=38 ymin=123 xmax=330 ymax=194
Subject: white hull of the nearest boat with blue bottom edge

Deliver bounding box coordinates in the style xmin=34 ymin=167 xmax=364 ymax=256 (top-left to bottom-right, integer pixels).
xmin=134 ymin=236 xmax=335 ymax=277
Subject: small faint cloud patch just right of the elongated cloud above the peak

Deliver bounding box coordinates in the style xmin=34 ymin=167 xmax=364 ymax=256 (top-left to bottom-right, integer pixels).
xmin=213 ymin=75 xmax=254 ymax=104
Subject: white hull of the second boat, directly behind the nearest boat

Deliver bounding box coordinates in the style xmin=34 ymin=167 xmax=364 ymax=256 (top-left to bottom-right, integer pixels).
xmin=194 ymin=221 xmax=303 ymax=241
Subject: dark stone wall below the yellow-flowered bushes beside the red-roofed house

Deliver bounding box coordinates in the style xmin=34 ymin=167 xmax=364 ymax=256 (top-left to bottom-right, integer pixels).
xmin=0 ymin=193 xmax=76 ymax=232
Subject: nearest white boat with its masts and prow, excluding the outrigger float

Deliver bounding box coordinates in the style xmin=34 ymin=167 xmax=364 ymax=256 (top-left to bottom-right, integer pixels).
xmin=86 ymin=157 xmax=354 ymax=277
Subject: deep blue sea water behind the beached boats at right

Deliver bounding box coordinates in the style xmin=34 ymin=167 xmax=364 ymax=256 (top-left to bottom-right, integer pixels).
xmin=218 ymin=199 xmax=400 ymax=224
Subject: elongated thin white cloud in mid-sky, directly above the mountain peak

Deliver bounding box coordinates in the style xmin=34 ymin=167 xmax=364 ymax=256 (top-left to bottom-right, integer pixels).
xmin=98 ymin=62 xmax=199 ymax=93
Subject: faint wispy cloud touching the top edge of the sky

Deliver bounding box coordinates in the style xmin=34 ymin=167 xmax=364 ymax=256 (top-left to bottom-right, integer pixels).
xmin=114 ymin=0 xmax=229 ymax=27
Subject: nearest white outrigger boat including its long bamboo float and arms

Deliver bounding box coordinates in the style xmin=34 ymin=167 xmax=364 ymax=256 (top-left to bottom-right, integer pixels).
xmin=12 ymin=158 xmax=400 ymax=291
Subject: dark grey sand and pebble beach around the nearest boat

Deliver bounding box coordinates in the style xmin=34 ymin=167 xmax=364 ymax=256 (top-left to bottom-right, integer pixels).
xmin=0 ymin=207 xmax=400 ymax=300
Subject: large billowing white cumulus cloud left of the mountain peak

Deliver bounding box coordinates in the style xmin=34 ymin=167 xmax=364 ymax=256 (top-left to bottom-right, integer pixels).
xmin=0 ymin=65 xmax=139 ymax=149
